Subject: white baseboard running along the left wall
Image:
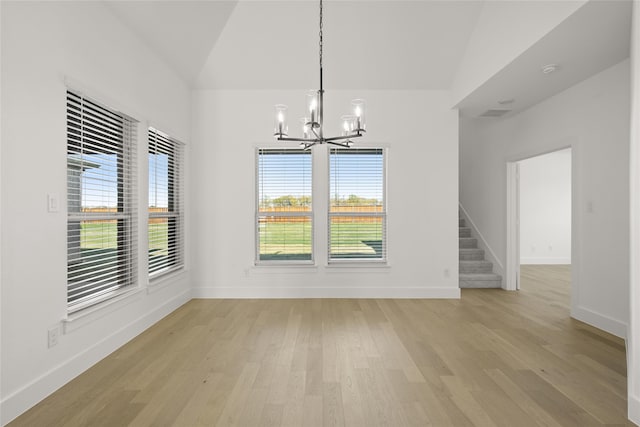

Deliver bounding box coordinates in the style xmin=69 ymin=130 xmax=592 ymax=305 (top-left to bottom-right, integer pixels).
xmin=0 ymin=289 xmax=191 ymax=425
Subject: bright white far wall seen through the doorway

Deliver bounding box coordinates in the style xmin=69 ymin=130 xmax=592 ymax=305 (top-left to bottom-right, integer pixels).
xmin=520 ymin=149 xmax=571 ymax=264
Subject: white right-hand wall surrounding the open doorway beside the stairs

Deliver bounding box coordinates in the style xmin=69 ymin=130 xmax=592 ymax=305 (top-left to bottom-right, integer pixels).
xmin=460 ymin=60 xmax=630 ymax=336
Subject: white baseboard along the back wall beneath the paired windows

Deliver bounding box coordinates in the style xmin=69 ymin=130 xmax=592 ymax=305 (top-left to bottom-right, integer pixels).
xmin=191 ymin=287 xmax=460 ymax=299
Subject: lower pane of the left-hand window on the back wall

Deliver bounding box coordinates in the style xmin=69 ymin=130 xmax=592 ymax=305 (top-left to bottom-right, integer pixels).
xmin=258 ymin=216 xmax=312 ymax=261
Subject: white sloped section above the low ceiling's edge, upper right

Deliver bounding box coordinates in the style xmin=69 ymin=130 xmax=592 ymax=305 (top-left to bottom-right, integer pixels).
xmin=452 ymin=0 xmax=586 ymax=105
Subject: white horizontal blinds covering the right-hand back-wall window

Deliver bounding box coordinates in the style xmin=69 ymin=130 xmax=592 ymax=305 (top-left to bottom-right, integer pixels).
xmin=329 ymin=148 xmax=387 ymax=261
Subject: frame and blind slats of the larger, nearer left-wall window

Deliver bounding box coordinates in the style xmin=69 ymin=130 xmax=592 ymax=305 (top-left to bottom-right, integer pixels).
xmin=65 ymin=88 xmax=139 ymax=314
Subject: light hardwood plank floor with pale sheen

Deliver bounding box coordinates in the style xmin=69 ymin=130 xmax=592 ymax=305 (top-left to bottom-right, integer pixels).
xmin=11 ymin=266 xmax=632 ymax=427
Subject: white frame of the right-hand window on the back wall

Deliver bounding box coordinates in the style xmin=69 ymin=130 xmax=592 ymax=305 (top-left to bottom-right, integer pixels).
xmin=327 ymin=146 xmax=389 ymax=265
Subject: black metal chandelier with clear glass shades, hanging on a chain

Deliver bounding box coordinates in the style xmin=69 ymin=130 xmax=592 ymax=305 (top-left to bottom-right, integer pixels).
xmin=273 ymin=0 xmax=365 ymax=150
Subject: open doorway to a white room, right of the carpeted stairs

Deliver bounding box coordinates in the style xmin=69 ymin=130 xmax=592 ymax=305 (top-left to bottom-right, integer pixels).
xmin=505 ymin=148 xmax=572 ymax=290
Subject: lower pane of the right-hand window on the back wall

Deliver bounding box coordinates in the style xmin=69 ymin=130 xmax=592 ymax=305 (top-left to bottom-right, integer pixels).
xmin=329 ymin=216 xmax=385 ymax=259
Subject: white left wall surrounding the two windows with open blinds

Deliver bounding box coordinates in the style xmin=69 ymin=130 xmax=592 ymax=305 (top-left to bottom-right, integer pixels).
xmin=1 ymin=1 xmax=190 ymax=424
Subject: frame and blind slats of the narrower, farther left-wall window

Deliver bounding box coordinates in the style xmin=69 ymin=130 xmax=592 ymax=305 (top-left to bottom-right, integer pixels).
xmin=146 ymin=126 xmax=185 ymax=282
